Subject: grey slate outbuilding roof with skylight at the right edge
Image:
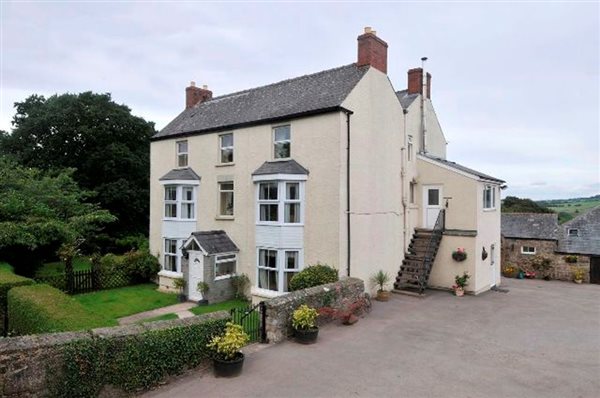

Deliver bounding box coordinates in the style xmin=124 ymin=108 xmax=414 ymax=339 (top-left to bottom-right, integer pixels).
xmin=558 ymin=206 xmax=600 ymax=255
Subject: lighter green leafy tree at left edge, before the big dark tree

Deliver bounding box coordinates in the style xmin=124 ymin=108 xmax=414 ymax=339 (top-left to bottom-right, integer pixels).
xmin=0 ymin=156 xmax=116 ymax=274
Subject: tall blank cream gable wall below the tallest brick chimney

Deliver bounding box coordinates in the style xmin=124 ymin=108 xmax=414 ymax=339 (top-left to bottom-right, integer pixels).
xmin=342 ymin=68 xmax=404 ymax=288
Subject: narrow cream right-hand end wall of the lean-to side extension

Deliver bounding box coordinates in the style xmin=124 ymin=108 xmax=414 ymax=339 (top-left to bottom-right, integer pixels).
xmin=476 ymin=182 xmax=501 ymax=293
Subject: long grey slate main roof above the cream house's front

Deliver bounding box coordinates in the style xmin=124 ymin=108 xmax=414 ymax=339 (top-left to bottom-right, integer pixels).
xmin=152 ymin=64 xmax=369 ymax=139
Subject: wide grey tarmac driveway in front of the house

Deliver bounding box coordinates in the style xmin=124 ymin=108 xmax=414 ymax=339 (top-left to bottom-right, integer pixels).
xmin=145 ymin=279 xmax=600 ymax=398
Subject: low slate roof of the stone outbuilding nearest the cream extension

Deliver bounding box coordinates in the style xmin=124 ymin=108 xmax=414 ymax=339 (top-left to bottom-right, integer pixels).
xmin=501 ymin=213 xmax=558 ymax=240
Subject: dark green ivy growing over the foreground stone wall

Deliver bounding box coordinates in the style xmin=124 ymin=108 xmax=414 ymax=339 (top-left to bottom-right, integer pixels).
xmin=51 ymin=319 xmax=228 ymax=397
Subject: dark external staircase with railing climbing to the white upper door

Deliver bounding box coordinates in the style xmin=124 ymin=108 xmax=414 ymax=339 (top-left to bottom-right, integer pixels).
xmin=394 ymin=210 xmax=445 ymax=295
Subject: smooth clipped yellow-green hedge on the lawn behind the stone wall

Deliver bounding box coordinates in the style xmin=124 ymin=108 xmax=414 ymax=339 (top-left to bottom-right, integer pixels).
xmin=7 ymin=284 xmax=107 ymax=335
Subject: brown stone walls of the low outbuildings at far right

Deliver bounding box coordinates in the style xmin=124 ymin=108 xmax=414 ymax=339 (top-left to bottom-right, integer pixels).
xmin=502 ymin=238 xmax=590 ymax=283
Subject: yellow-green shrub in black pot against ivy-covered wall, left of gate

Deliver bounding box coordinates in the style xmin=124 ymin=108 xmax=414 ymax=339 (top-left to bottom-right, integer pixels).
xmin=207 ymin=322 xmax=250 ymax=377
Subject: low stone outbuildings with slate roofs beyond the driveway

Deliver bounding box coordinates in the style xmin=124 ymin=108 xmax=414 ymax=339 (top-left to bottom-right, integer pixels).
xmin=502 ymin=207 xmax=600 ymax=283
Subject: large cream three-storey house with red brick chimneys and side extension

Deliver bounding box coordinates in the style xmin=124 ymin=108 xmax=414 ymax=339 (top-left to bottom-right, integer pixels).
xmin=150 ymin=28 xmax=504 ymax=300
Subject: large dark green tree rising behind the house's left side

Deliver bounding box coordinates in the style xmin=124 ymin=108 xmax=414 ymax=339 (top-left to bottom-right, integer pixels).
xmin=0 ymin=92 xmax=155 ymax=244
